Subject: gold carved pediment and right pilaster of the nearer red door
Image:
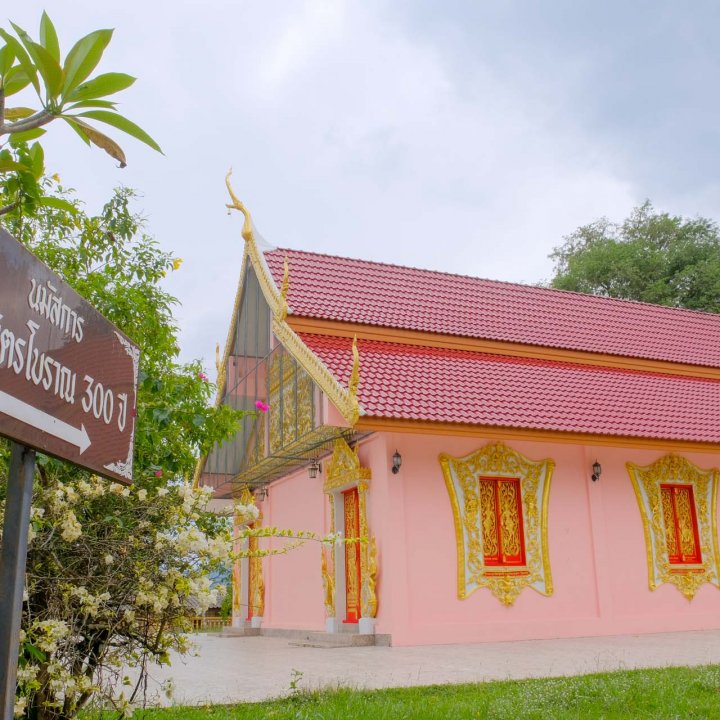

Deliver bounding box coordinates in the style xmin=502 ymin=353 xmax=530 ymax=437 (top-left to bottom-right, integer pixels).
xmin=323 ymin=438 xmax=378 ymax=618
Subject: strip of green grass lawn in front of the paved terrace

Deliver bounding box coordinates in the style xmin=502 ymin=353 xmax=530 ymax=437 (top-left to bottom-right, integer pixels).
xmin=90 ymin=665 xmax=720 ymax=720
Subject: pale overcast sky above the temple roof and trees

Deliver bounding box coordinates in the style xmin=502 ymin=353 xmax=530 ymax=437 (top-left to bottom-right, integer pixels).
xmin=9 ymin=0 xmax=720 ymax=368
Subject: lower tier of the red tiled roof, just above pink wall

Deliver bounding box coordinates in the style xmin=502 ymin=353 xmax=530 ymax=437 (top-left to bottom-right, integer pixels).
xmin=301 ymin=334 xmax=720 ymax=443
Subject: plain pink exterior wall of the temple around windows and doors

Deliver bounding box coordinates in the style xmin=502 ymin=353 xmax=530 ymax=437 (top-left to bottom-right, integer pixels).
xmin=264 ymin=433 xmax=720 ymax=645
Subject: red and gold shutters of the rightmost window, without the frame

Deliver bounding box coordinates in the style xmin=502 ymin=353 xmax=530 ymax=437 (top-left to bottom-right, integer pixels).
xmin=660 ymin=484 xmax=702 ymax=565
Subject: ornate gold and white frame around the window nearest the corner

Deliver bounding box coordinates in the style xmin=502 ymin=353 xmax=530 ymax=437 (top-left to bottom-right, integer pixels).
xmin=439 ymin=443 xmax=555 ymax=605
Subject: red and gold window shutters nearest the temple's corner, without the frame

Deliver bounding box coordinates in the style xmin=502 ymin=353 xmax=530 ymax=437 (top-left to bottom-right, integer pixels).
xmin=480 ymin=477 xmax=526 ymax=567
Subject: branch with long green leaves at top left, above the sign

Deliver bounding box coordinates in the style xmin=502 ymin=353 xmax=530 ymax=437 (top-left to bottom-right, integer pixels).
xmin=0 ymin=13 xmax=162 ymax=216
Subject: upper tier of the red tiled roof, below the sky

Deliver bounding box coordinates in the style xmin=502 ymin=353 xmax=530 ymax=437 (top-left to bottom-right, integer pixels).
xmin=265 ymin=249 xmax=720 ymax=367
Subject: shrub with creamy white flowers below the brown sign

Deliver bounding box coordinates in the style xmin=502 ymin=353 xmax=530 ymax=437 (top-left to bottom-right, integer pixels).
xmin=0 ymin=472 xmax=231 ymax=720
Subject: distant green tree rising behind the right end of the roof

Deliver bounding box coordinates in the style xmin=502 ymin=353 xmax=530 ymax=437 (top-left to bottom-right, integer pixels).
xmin=550 ymin=202 xmax=720 ymax=312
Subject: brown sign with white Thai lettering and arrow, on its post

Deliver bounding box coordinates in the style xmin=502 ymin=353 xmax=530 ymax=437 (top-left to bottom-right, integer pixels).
xmin=0 ymin=229 xmax=140 ymax=720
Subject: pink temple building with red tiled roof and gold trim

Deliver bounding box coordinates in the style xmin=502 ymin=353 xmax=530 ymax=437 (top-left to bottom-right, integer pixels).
xmin=197 ymin=198 xmax=720 ymax=645
